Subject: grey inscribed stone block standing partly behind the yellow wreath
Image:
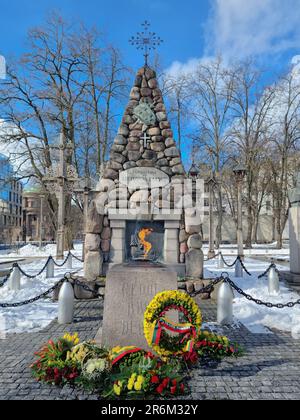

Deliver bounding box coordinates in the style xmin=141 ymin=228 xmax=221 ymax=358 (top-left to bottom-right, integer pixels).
xmin=95 ymin=263 xmax=177 ymax=350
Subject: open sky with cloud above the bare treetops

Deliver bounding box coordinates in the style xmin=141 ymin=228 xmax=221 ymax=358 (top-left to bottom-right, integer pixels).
xmin=0 ymin=0 xmax=300 ymax=77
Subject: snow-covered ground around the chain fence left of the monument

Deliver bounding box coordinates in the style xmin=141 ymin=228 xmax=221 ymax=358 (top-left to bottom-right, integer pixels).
xmin=0 ymin=254 xmax=82 ymax=336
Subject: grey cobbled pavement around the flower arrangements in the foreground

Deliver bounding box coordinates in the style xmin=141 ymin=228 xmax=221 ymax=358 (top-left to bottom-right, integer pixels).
xmin=0 ymin=301 xmax=300 ymax=400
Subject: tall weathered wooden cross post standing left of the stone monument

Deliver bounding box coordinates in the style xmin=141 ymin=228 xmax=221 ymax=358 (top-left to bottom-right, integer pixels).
xmin=44 ymin=133 xmax=78 ymax=260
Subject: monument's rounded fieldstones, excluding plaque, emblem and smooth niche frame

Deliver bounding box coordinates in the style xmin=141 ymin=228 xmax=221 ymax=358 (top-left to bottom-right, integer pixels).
xmin=85 ymin=66 xmax=203 ymax=278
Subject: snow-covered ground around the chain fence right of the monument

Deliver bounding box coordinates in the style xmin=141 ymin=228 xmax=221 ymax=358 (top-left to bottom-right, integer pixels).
xmin=205 ymin=257 xmax=300 ymax=334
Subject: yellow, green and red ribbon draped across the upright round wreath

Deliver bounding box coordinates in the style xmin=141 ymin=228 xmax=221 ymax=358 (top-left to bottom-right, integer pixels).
xmin=152 ymin=318 xmax=197 ymax=353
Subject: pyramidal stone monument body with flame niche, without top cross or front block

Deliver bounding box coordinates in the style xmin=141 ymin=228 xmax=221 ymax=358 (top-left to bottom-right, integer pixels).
xmin=85 ymin=66 xmax=203 ymax=281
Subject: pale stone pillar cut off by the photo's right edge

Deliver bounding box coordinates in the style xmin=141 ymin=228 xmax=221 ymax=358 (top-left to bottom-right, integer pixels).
xmin=289 ymin=203 xmax=300 ymax=276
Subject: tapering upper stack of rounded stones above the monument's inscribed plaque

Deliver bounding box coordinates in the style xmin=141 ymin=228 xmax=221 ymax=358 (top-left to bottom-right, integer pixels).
xmin=104 ymin=67 xmax=185 ymax=180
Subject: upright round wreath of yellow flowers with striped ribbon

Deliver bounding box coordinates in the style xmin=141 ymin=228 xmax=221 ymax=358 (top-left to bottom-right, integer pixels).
xmin=144 ymin=290 xmax=202 ymax=357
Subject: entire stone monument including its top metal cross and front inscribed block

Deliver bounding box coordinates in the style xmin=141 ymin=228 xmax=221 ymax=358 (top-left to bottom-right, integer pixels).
xmin=85 ymin=22 xmax=203 ymax=348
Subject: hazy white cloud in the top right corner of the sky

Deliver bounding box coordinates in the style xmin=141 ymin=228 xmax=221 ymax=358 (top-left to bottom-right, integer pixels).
xmin=207 ymin=0 xmax=300 ymax=60
